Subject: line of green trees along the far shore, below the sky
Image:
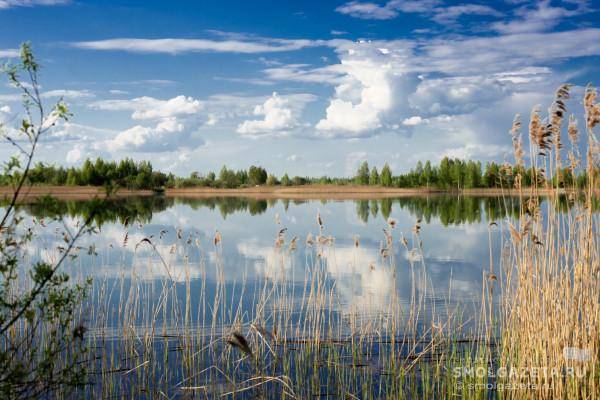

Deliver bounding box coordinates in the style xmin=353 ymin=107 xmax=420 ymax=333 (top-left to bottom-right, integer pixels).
xmin=0 ymin=157 xmax=586 ymax=190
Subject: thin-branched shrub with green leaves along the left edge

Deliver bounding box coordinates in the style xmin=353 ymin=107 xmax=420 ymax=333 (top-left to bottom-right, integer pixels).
xmin=0 ymin=44 xmax=90 ymax=399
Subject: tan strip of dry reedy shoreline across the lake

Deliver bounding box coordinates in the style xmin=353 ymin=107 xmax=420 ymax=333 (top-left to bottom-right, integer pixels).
xmin=0 ymin=185 xmax=584 ymax=200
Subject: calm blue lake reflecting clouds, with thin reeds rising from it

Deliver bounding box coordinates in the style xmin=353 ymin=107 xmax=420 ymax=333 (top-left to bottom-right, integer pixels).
xmin=7 ymin=195 xmax=584 ymax=398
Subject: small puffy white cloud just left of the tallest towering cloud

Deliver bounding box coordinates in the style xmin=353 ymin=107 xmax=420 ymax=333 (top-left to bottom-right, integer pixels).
xmin=237 ymin=92 xmax=298 ymax=136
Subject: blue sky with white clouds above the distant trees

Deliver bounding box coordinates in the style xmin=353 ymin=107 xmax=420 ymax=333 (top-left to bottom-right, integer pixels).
xmin=0 ymin=0 xmax=600 ymax=176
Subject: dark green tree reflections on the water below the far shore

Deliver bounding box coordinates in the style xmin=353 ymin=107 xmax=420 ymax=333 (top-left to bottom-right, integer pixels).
xmin=0 ymin=196 xmax=600 ymax=225
